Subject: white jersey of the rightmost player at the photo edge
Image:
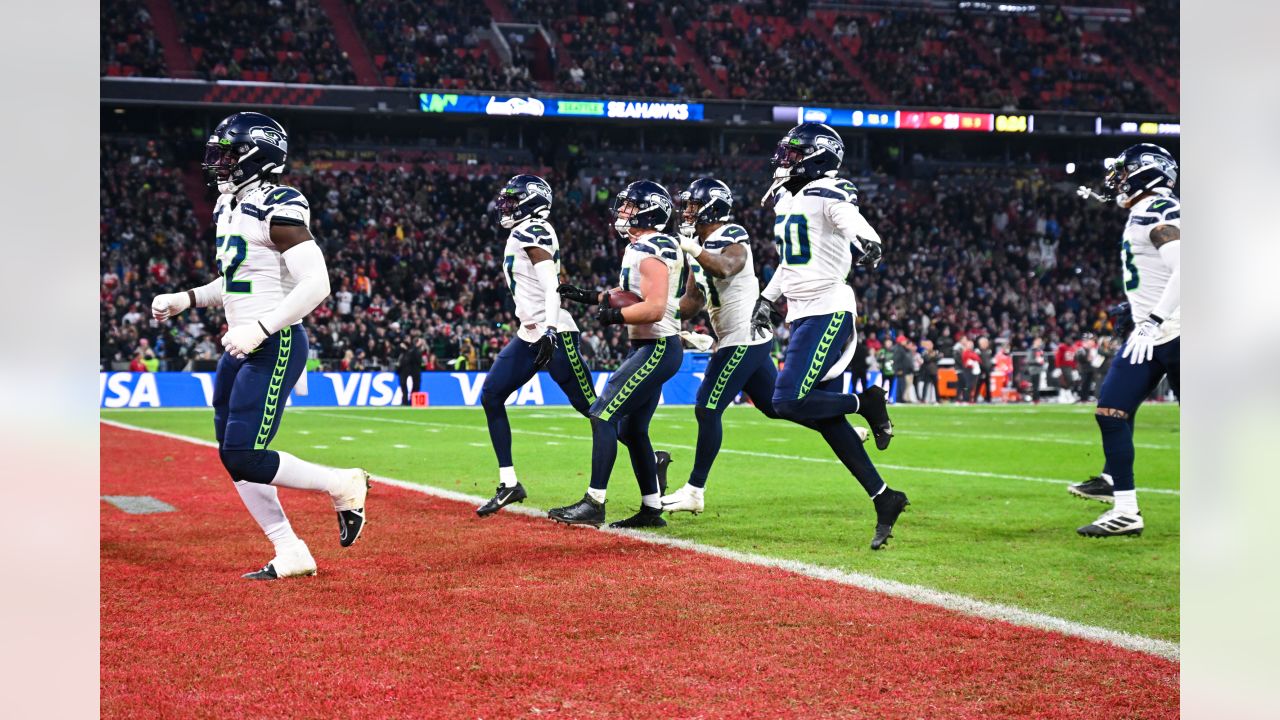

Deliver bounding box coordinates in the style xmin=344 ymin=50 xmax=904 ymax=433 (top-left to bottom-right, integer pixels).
xmin=1120 ymin=193 xmax=1183 ymax=345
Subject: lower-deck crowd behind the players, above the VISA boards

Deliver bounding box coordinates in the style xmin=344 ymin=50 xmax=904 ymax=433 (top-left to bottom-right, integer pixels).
xmin=101 ymin=128 xmax=1136 ymax=397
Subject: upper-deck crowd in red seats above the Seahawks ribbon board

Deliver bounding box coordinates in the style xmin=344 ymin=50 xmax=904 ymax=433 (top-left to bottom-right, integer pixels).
xmin=101 ymin=0 xmax=1179 ymax=113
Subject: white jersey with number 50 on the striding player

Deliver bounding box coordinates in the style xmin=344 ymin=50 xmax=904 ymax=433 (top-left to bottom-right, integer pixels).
xmin=771 ymin=178 xmax=879 ymax=317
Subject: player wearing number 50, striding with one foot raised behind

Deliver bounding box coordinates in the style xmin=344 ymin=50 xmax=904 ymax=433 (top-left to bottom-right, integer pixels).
xmin=751 ymin=123 xmax=908 ymax=550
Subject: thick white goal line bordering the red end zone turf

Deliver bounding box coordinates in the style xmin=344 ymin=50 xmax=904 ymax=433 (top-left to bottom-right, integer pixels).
xmin=99 ymin=420 xmax=1180 ymax=662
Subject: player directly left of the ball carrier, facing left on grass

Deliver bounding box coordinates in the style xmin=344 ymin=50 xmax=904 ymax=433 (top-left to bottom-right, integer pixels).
xmin=476 ymin=174 xmax=595 ymax=518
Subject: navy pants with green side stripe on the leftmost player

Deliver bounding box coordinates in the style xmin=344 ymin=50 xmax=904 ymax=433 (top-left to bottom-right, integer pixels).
xmin=214 ymin=324 xmax=307 ymax=483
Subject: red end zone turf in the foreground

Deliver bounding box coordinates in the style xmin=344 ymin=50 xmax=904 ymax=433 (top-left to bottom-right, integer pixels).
xmin=101 ymin=425 xmax=1179 ymax=719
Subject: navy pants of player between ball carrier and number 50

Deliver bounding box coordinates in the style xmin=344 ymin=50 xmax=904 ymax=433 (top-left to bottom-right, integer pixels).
xmin=689 ymin=342 xmax=778 ymax=487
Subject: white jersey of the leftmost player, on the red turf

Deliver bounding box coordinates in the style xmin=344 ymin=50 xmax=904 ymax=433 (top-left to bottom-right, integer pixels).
xmin=214 ymin=183 xmax=311 ymax=328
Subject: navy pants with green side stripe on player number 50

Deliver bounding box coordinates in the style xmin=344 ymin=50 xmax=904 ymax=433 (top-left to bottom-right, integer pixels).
xmin=773 ymin=311 xmax=884 ymax=497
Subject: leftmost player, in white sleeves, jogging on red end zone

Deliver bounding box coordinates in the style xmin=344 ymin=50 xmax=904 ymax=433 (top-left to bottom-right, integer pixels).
xmin=151 ymin=113 xmax=369 ymax=580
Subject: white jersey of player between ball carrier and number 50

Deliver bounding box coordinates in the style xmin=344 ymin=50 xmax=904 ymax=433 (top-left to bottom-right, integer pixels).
xmin=689 ymin=223 xmax=773 ymax=347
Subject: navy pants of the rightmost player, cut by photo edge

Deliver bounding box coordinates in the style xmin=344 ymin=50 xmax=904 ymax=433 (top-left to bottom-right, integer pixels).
xmin=1094 ymin=337 xmax=1181 ymax=491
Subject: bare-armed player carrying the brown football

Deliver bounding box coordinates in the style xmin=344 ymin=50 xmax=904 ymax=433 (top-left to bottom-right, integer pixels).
xmin=548 ymin=181 xmax=686 ymax=528
